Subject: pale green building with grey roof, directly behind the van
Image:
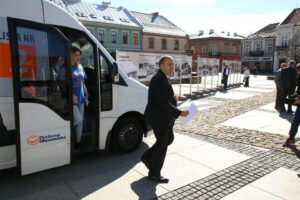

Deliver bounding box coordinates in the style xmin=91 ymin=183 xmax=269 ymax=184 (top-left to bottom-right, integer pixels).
xmin=54 ymin=0 xmax=143 ymax=56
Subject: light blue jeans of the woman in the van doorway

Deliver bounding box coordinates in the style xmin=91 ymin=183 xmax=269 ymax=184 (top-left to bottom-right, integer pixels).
xmin=73 ymin=103 xmax=84 ymax=139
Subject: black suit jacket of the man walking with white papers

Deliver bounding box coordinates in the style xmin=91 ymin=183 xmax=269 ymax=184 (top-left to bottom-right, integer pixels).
xmin=145 ymin=69 xmax=181 ymax=129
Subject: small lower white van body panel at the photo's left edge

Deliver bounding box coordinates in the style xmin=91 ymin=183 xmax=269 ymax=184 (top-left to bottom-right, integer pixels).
xmin=0 ymin=145 xmax=17 ymax=170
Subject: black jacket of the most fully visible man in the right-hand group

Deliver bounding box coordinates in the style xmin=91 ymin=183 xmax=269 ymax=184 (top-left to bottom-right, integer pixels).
xmin=281 ymin=66 xmax=297 ymax=92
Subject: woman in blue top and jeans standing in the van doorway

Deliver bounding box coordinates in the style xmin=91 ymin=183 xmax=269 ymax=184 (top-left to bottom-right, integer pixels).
xmin=71 ymin=47 xmax=88 ymax=149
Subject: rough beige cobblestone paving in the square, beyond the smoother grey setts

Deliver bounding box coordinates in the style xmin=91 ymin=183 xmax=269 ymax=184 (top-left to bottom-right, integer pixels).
xmin=174 ymin=87 xmax=300 ymax=154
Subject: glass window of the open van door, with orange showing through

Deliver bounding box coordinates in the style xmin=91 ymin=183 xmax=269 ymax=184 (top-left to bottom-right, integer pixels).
xmin=17 ymin=27 xmax=70 ymax=119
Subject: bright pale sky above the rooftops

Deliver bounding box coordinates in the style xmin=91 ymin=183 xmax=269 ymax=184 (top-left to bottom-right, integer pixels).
xmin=82 ymin=0 xmax=300 ymax=36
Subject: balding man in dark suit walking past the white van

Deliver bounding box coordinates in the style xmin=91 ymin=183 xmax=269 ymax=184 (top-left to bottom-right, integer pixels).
xmin=141 ymin=56 xmax=188 ymax=183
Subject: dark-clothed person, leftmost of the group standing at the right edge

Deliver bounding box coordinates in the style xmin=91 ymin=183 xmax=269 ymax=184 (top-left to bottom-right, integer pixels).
xmin=274 ymin=63 xmax=287 ymax=112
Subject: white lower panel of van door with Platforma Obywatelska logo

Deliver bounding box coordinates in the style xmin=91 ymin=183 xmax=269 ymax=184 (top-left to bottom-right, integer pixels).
xmin=19 ymin=103 xmax=71 ymax=175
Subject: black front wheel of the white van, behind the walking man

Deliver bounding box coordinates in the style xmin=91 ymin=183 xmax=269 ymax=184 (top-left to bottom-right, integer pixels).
xmin=112 ymin=117 xmax=143 ymax=153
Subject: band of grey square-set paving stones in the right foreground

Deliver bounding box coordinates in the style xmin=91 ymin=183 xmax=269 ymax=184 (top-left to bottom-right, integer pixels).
xmin=155 ymin=132 xmax=300 ymax=200
